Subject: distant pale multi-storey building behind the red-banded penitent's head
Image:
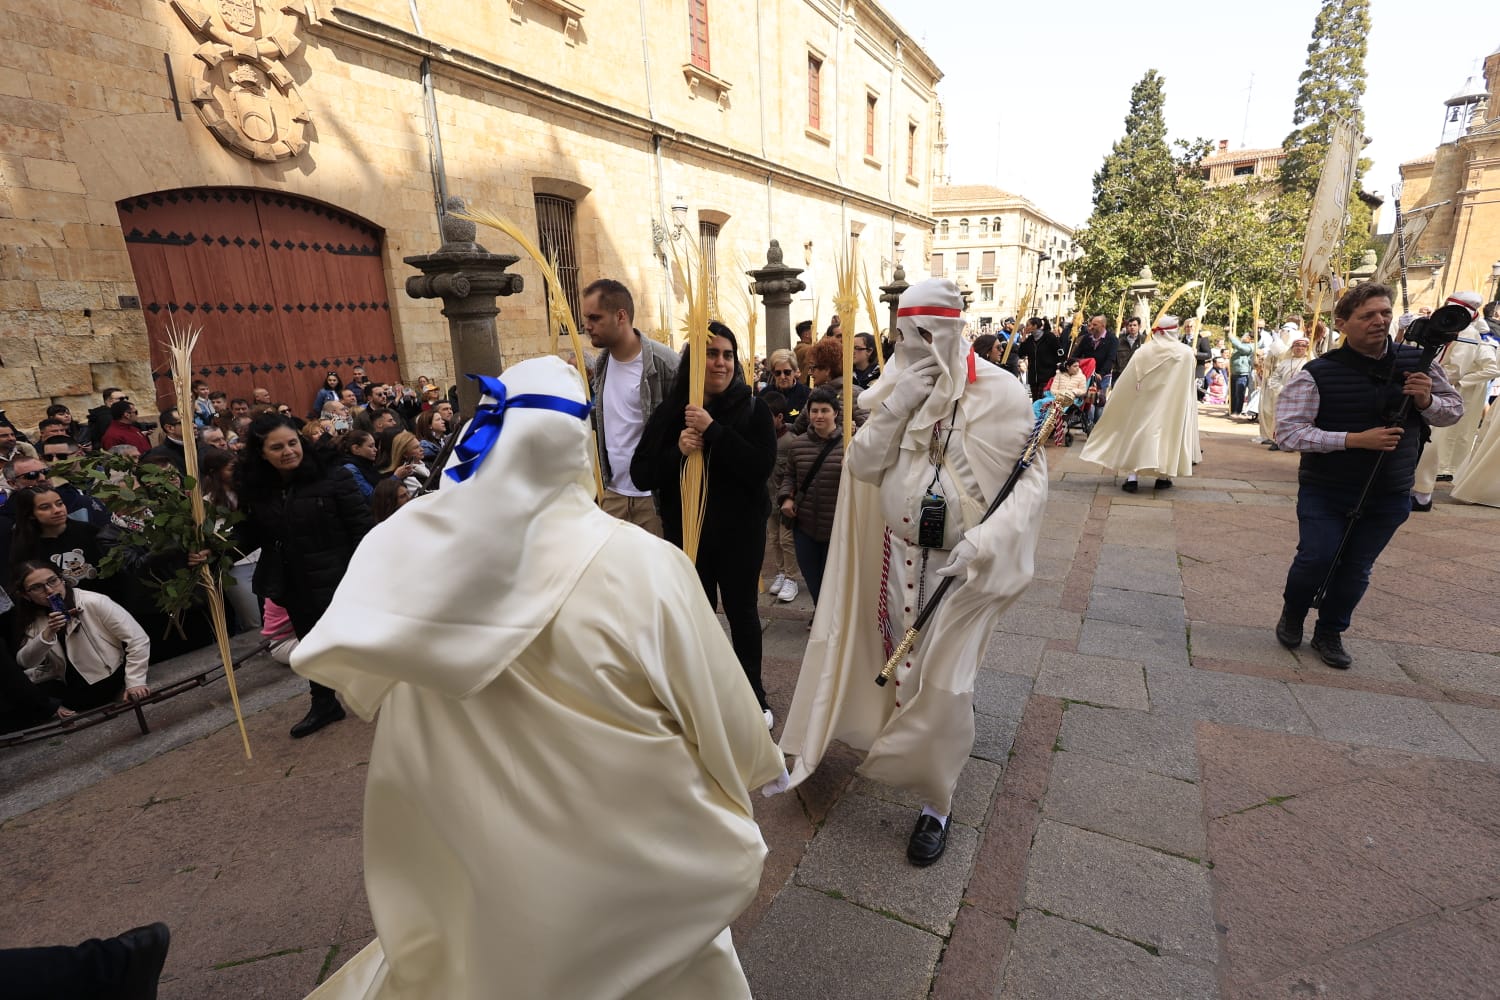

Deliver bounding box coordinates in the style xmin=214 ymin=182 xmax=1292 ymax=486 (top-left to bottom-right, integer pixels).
xmin=927 ymin=184 xmax=1077 ymax=331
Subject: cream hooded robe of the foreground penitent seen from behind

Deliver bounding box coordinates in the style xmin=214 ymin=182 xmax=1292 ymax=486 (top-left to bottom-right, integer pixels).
xmin=293 ymin=357 xmax=782 ymax=1000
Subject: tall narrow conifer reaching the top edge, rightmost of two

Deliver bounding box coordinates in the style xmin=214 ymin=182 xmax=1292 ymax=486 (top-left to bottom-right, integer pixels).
xmin=1280 ymin=0 xmax=1370 ymax=198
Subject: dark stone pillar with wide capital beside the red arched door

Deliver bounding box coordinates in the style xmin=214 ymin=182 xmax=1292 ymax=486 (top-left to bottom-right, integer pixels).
xmin=405 ymin=198 xmax=522 ymax=417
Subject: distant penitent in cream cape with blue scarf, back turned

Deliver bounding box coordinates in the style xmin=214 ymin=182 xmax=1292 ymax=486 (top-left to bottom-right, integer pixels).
xmin=1079 ymin=336 xmax=1200 ymax=478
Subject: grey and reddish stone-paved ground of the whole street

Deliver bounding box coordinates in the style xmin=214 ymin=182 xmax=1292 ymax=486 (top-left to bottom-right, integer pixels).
xmin=0 ymin=415 xmax=1500 ymax=1000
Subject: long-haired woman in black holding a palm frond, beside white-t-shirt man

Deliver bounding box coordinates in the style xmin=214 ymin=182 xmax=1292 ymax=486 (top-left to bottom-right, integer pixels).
xmin=630 ymin=322 xmax=776 ymax=726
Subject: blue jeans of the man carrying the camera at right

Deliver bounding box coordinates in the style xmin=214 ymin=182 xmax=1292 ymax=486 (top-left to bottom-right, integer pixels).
xmin=1283 ymin=483 xmax=1412 ymax=633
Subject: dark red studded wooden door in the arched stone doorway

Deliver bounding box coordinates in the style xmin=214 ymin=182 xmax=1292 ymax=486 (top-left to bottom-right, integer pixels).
xmin=117 ymin=187 xmax=398 ymax=417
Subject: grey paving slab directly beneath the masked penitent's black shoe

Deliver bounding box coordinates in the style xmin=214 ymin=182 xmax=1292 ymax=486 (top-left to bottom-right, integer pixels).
xmin=794 ymin=795 xmax=980 ymax=936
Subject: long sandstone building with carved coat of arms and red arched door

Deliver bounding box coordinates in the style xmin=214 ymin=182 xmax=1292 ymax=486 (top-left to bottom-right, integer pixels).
xmin=0 ymin=0 xmax=941 ymax=429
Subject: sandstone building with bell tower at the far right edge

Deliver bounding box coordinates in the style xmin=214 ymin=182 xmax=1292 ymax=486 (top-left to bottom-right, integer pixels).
xmin=1401 ymin=48 xmax=1500 ymax=309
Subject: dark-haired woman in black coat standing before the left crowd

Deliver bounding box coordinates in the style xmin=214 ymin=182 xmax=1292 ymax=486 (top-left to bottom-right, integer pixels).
xmin=236 ymin=414 xmax=371 ymax=739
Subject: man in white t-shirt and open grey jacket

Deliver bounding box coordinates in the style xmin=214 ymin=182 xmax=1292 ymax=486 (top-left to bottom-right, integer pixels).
xmin=584 ymin=277 xmax=678 ymax=537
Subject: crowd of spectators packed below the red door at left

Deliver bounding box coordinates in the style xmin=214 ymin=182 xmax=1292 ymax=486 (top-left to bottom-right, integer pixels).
xmin=0 ymin=367 xmax=458 ymax=736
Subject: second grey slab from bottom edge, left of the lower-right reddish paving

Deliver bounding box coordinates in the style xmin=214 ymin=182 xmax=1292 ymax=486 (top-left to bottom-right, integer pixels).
xmin=1026 ymin=819 xmax=1217 ymax=963
